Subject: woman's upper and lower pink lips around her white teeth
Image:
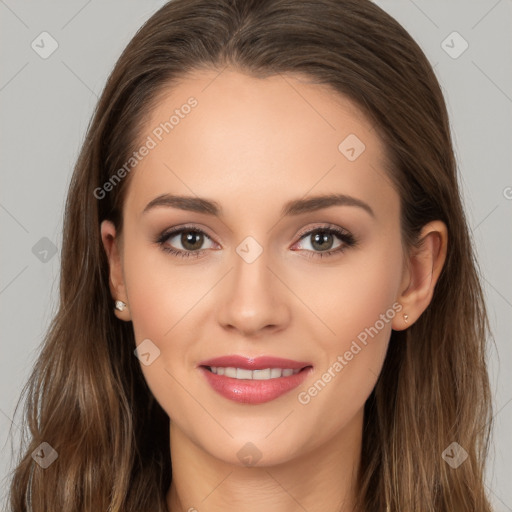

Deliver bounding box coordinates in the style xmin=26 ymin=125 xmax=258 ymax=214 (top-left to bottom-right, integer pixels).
xmin=198 ymin=355 xmax=313 ymax=404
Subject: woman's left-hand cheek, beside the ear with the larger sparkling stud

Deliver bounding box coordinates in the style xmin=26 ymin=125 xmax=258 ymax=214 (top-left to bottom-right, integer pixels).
xmin=124 ymin=242 xmax=202 ymax=417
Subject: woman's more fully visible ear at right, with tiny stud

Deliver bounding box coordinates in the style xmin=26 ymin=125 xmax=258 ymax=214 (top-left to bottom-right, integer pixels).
xmin=392 ymin=220 xmax=448 ymax=331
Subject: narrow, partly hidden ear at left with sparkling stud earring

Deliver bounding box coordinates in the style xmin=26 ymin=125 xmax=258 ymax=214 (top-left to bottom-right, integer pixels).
xmin=101 ymin=220 xmax=131 ymax=322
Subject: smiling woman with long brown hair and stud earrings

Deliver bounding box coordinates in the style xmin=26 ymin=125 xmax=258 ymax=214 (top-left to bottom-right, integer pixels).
xmin=5 ymin=0 xmax=491 ymax=512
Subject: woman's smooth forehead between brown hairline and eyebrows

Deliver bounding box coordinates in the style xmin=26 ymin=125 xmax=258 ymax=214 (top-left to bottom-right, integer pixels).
xmin=125 ymin=65 xmax=397 ymax=220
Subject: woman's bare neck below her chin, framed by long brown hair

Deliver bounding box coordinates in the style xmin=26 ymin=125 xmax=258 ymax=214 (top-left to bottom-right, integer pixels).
xmin=167 ymin=410 xmax=363 ymax=512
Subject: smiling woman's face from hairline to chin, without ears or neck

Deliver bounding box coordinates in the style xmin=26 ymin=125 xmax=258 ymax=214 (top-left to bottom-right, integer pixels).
xmin=105 ymin=69 xmax=404 ymax=465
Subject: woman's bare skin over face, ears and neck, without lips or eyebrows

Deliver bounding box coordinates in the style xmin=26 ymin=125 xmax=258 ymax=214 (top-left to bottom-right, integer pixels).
xmin=101 ymin=68 xmax=447 ymax=512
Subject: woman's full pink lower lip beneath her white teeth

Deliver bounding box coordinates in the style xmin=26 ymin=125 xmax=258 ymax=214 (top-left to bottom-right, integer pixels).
xmin=199 ymin=366 xmax=313 ymax=404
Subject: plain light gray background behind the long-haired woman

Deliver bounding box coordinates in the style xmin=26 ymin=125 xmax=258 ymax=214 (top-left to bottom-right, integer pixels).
xmin=0 ymin=0 xmax=512 ymax=511
